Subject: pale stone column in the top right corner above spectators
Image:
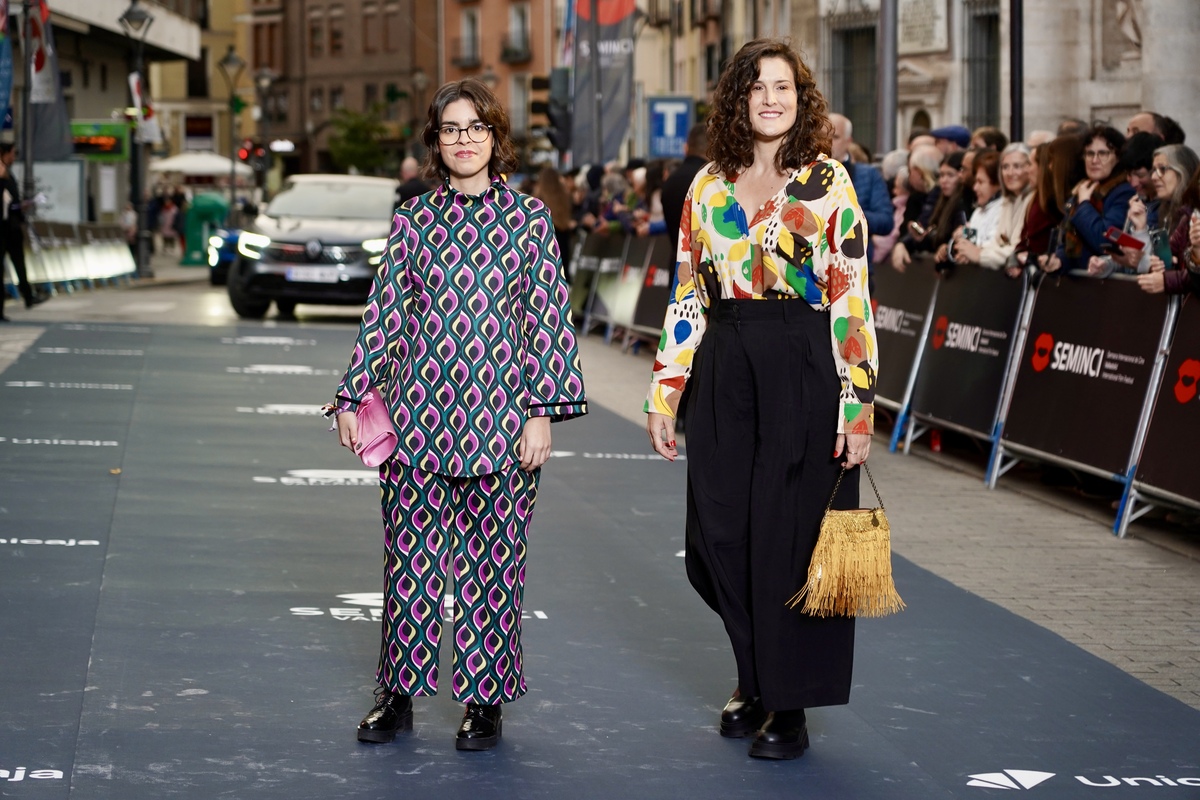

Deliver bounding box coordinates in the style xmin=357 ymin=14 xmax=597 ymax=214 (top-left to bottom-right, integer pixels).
xmin=1140 ymin=0 xmax=1200 ymax=142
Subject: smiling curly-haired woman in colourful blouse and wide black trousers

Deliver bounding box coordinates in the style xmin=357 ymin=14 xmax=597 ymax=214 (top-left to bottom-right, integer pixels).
xmin=646 ymin=40 xmax=878 ymax=758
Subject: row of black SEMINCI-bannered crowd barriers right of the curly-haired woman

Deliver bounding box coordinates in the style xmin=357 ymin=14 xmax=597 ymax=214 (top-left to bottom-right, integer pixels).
xmin=872 ymin=259 xmax=1200 ymax=536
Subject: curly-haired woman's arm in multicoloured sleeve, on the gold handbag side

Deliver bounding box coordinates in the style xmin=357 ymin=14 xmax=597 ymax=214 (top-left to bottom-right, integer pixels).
xmin=815 ymin=163 xmax=880 ymax=467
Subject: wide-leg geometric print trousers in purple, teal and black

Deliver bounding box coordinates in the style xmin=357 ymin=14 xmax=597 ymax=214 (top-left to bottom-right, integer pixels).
xmin=376 ymin=458 xmax=541 ymax=705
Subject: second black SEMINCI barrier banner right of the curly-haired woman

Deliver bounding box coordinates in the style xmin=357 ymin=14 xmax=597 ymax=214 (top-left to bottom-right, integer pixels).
xmin=907 ymin=263 xmax=1027 ymax=439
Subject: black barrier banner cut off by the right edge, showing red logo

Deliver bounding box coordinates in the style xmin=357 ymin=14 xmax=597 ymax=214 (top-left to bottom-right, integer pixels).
xmin=1136 ymin=297 xmax=1200 ymax=503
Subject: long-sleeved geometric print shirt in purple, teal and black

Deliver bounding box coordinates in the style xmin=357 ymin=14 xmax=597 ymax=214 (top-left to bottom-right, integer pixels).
xmin=335 ymin=179 xmax=587 ymax=476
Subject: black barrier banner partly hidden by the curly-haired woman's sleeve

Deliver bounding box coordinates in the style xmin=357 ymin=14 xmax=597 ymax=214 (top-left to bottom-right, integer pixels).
xmin=871 ymin=255 xmax=937 ymax=404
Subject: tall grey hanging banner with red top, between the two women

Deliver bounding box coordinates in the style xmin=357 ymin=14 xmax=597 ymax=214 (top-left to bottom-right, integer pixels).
xmin=571 ymin=0 xmax=637 ymax=164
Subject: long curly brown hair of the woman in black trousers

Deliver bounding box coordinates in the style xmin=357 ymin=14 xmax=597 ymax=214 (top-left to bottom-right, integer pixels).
xmin=708 ymin=38 xmax=833 ymax=175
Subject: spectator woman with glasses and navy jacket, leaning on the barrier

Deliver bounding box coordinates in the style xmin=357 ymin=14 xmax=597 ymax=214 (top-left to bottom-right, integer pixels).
xmin=1038 ymin=125 xmax=1134 ymax=272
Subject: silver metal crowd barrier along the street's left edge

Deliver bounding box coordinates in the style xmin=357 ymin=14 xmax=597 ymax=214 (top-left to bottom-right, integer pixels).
xmin=6 ymin=219 xmax=137 ymax=291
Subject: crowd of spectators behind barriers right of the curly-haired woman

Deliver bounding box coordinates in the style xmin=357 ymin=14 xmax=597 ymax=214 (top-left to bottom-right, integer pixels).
xmin=871 ymin=112 xmax=1200 ymax=294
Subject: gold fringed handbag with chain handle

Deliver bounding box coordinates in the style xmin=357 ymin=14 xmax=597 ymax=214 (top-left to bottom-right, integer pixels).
xmin=787 ymin=463 xmax=905 ymax=616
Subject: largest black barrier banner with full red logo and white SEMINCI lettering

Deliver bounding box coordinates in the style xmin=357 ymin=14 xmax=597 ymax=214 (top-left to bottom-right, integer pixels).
xmin=1001 ymin=276 xmax=1168 ymax=475
